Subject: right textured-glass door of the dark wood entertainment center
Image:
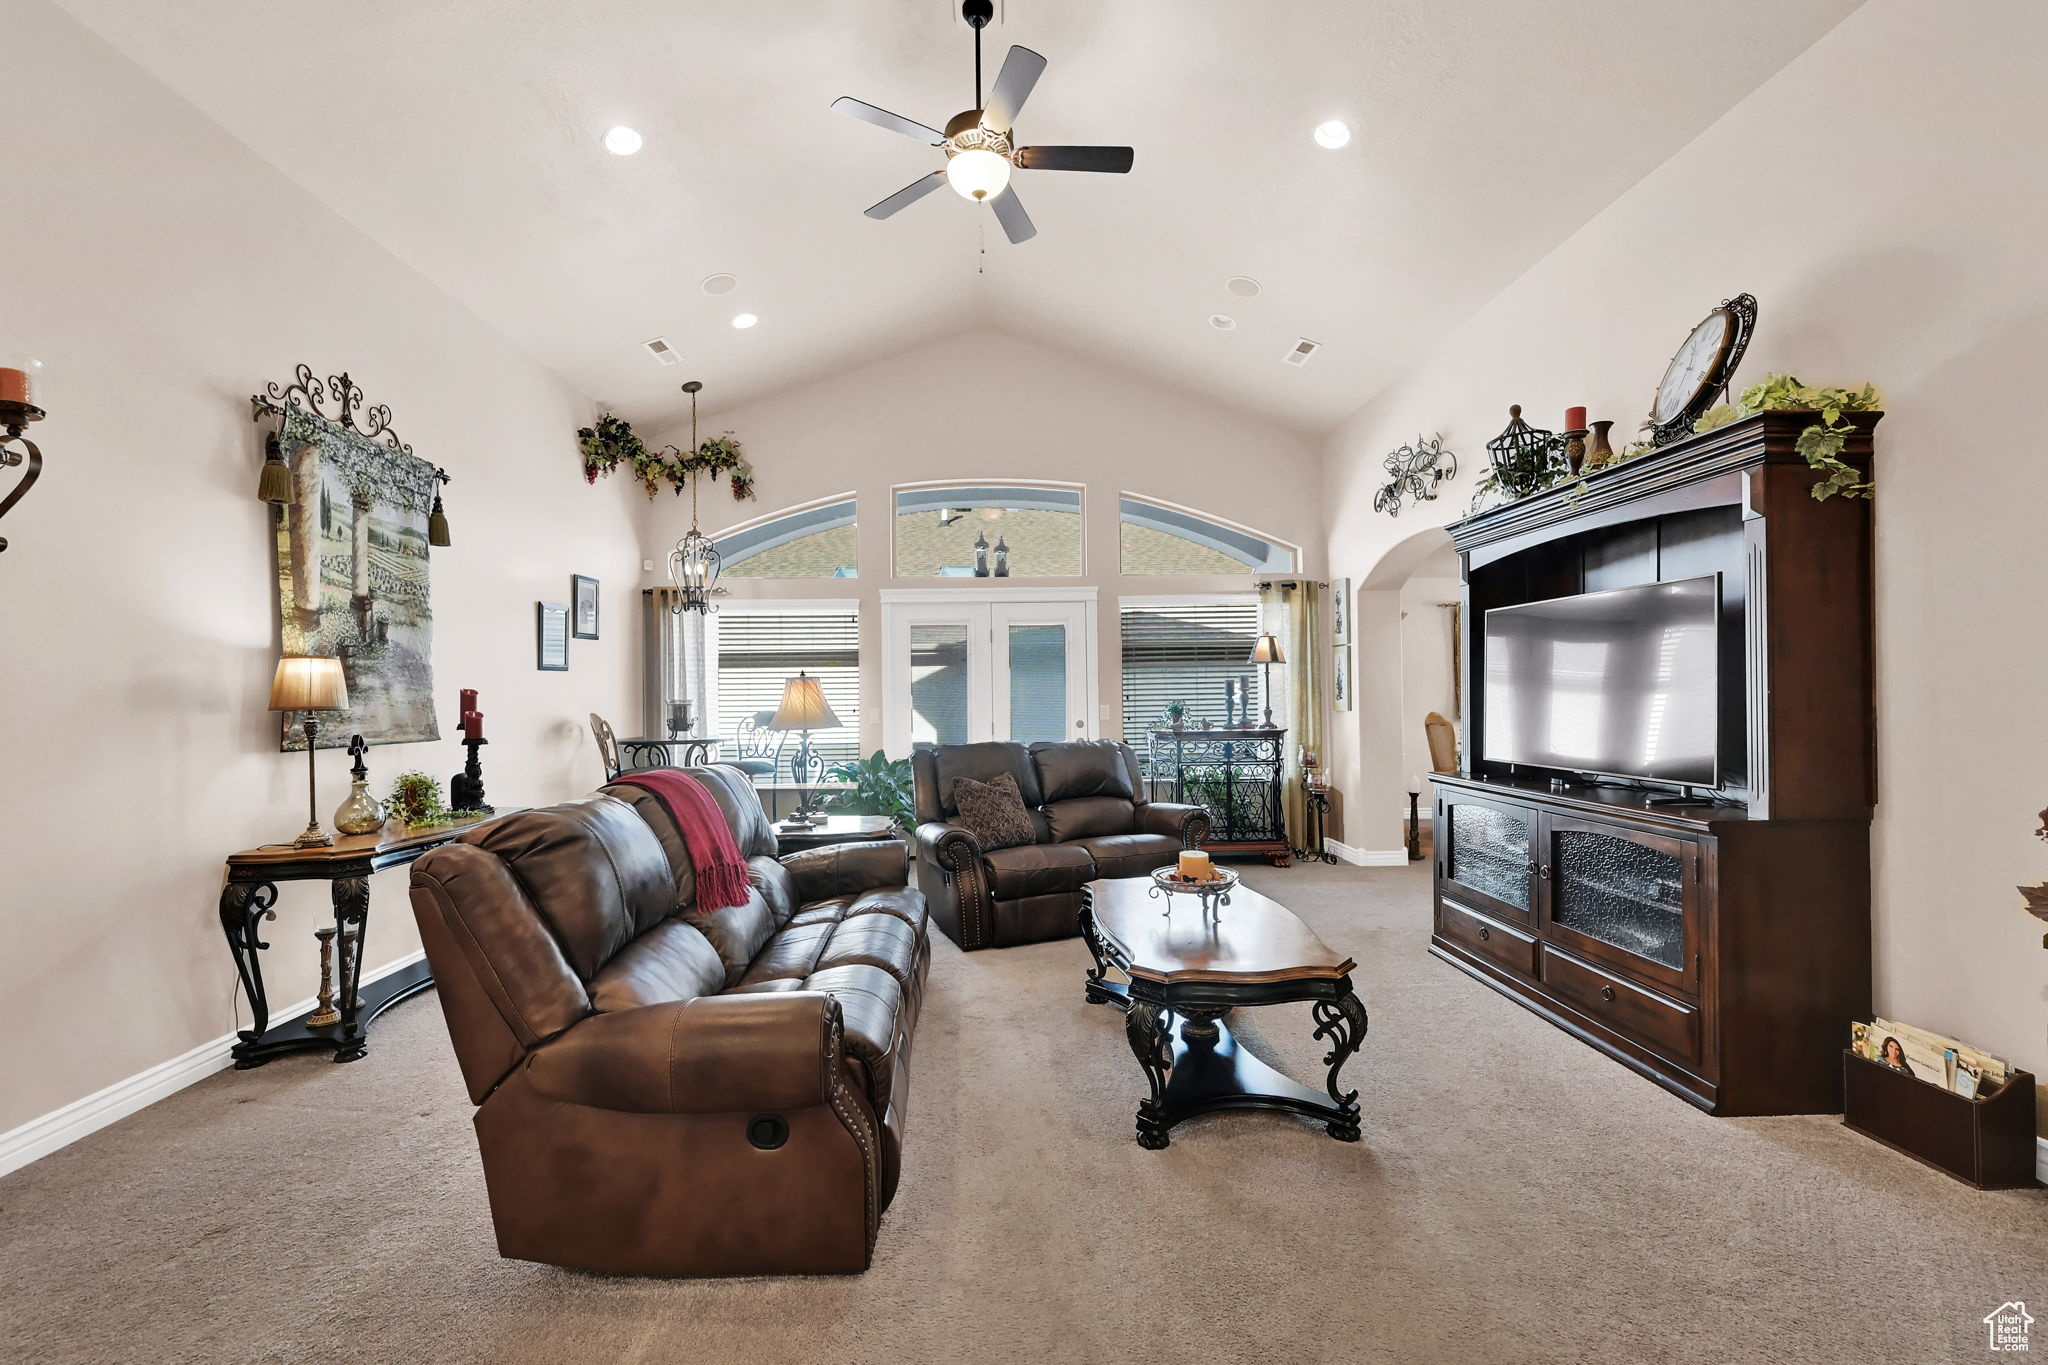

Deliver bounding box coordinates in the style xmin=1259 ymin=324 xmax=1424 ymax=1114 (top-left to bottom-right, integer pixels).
xmin=1544 ymin=814 xmax=1698 ymax=988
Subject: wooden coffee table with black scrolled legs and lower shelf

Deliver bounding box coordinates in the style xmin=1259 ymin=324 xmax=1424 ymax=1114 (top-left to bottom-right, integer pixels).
xmin=1081 ymin=878 xmax=1366 ymax=1150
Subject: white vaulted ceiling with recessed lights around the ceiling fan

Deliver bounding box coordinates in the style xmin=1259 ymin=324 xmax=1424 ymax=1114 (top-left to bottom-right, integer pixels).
xmin=59 ymin=0 xmax=1858 ymax=432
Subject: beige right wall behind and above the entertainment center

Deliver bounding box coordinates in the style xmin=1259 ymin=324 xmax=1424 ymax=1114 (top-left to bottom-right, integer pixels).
xmin=1327 ymin=0 xmax=2048 ymax=1113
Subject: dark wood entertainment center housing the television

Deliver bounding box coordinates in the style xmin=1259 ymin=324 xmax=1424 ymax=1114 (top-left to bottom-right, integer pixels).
xmin=1430 ymin=413 xmax=1882 ymax=1115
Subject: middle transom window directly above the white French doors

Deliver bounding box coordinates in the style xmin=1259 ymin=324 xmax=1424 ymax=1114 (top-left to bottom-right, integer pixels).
xmin=895 ymin=483 xmax=1081 ymax=579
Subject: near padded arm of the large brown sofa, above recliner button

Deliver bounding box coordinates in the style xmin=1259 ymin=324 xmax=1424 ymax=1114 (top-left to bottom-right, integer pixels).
xmin=526 ymin=990 xmax=840 ymax=1113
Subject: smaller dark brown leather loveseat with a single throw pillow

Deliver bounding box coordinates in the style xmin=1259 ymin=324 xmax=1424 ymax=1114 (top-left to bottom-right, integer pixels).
xmin=909 ymin=739 xmax=1208 ymax=952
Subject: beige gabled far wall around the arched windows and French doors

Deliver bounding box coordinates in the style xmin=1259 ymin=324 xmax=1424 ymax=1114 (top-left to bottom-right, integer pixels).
xmin=645 ymin=329 xmax=1323 ymax=753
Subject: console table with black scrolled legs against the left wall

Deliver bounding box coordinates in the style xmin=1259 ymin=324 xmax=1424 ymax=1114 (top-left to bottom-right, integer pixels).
xmin=221 ymin=817 xmax=498 ymax=1070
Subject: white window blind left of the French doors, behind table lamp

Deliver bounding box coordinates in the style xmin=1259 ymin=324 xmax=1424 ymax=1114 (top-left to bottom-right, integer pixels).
xmin=711 ymin=602 xmax=860 ymax=782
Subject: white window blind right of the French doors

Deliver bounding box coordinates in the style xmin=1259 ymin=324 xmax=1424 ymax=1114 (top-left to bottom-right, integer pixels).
xmin=1122 ymin=598 xmax=1260 ymax=740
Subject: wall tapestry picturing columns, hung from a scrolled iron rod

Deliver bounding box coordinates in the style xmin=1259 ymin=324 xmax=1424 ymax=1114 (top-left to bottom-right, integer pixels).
xmin=272 ymin=401 xmax=440 ymax=751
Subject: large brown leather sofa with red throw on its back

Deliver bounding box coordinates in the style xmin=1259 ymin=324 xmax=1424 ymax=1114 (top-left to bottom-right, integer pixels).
xmin=412 ymin=767 xmax=932 ymax=1275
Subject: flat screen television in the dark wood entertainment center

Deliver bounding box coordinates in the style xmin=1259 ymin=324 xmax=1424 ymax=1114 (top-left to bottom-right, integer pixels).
xmin=1481 ymin=573 xmax=1720 ymax=786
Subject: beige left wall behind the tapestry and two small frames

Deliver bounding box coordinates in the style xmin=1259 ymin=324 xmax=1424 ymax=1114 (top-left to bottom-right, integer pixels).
xmin=0 ymin=2 xmax=639 ymax=1132
